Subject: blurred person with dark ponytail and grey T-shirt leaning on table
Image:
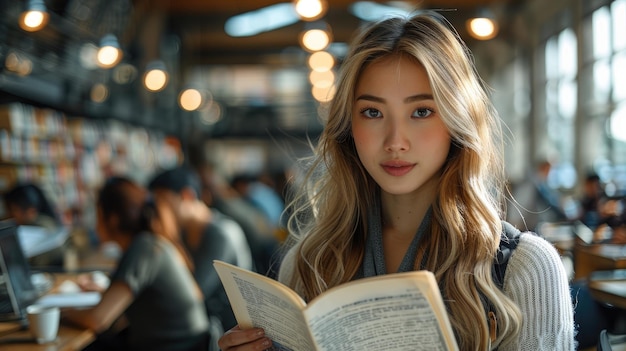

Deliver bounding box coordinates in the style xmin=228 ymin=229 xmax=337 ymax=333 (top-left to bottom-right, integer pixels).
xmin=63 ymin=177 xmax=209 ymax=351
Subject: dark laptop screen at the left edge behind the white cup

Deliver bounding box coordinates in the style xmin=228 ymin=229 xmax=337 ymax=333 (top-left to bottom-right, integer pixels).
xmin=0 ymin=221 xmax=39 ymax=321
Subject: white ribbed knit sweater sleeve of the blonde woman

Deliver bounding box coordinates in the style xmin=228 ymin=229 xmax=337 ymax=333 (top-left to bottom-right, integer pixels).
xmin=499 ymin=233 xmax=576 ymax=351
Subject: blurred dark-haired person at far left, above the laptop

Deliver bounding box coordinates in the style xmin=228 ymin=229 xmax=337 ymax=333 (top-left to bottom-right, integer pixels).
xmin=3 ymin=183 xmax=62 ymax=230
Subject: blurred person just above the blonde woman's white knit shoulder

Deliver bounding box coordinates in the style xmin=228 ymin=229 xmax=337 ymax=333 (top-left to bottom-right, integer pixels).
xmin=506 ymin=160 xmax=569 ymax=234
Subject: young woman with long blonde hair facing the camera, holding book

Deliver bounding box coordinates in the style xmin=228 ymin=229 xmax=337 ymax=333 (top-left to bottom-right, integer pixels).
xmin=219 ymin=13 xmax=575 ymax=350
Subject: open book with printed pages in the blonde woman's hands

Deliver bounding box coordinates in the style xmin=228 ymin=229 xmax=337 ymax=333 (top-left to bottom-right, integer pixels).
xmin=213 ymin=261 xmax=458 ymax=351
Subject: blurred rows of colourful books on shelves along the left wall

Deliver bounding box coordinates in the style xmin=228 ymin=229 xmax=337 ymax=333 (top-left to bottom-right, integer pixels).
xmin=0 ymin=103 xmax=182 ymax=223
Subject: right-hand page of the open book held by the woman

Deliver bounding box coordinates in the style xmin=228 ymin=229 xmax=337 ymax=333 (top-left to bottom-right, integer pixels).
xmin=305 ymin=272 xmax=458 ymax=351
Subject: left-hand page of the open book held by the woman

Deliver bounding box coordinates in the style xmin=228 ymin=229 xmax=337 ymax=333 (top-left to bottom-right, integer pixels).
xmin=214 ymin=261 xmax=314 ymax=351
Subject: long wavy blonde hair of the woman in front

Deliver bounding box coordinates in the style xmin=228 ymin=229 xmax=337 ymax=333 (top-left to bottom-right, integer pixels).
xmin=281 ymin=12 xmax=521 ymax=350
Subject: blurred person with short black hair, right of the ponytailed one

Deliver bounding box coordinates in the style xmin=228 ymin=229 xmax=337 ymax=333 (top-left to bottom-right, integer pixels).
xmin=148 ymin=166 xmax=253 ymax=337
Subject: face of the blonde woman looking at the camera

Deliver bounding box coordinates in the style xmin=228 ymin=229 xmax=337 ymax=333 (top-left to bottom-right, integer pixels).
xmin=352 ymin=55 xmax=450 ymax=195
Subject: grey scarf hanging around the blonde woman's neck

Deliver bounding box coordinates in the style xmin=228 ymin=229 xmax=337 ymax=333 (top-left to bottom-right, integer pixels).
xmin=355 ymin=201 xmax=432 ymax=278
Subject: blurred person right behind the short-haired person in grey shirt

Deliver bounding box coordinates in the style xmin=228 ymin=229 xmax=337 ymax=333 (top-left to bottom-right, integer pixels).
xmin=195 ymin=162 xmax=280 ymax=277
